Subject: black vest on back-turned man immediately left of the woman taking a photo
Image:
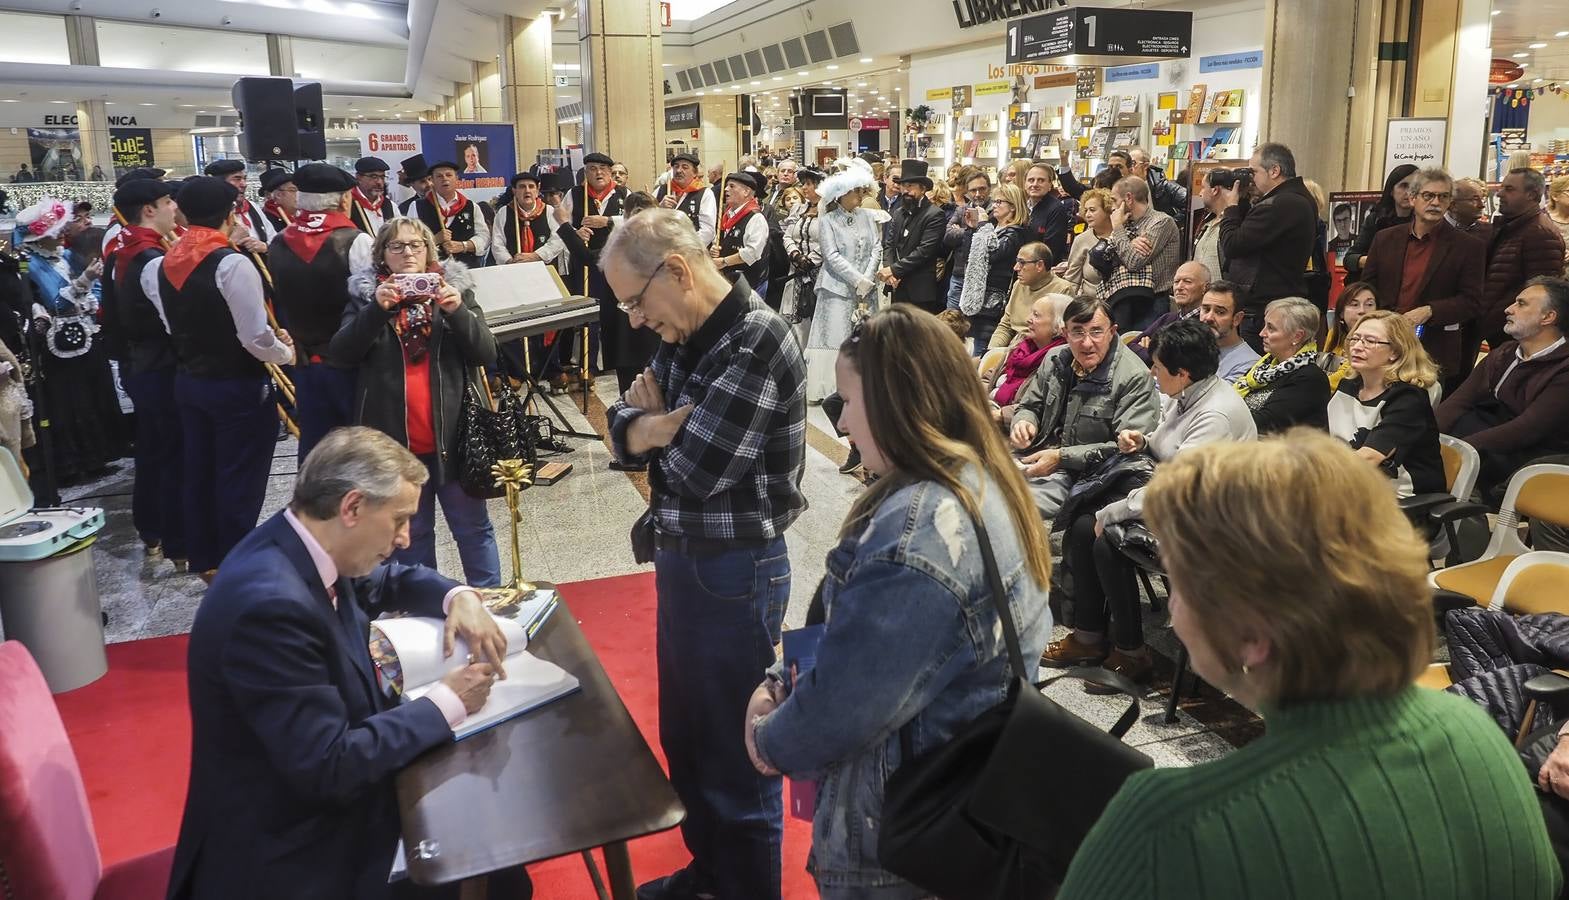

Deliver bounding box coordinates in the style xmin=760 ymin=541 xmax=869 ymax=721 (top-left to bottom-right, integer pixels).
xmin=267 ymin=227 xmax=359 ymax=364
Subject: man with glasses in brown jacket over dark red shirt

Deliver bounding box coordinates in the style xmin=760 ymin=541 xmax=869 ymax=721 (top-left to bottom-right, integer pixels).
xmin=1362 ymin=168 xmax=1487 ymax=392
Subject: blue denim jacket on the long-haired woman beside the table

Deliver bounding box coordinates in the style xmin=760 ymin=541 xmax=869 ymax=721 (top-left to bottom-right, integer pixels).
xmin=756 ymin=469 xmax=1051 ymax=889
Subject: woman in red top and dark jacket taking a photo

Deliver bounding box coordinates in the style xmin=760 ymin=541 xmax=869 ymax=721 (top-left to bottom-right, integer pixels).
xmin=331 ymin=218 xmax=501 ymax=588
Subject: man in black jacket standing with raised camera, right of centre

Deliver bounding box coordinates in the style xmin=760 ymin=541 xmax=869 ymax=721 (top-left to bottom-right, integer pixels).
xmin=1221 ymin=143 xmax=1318 ymax=351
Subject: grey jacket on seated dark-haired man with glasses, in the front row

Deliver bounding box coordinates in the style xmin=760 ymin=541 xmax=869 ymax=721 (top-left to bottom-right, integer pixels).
xmin=1014 ymin=337 xmax=1161 ymax=474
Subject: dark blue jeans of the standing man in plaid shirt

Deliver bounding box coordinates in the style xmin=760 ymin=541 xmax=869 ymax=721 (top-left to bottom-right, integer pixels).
xmin=654 ymin=538 xmax=789 ymax=900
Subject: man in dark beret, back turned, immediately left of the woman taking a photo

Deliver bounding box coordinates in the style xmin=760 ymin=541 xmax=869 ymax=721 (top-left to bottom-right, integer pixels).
xmin=267 ymin=163 xmax=375 ymax=461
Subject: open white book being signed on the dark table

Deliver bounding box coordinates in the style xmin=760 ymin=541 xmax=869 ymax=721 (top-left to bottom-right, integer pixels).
xmin=370 ymin=590 xmax=579 ymax=740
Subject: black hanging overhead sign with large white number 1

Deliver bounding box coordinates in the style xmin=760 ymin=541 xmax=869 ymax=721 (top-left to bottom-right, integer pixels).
xmin=1007 ymin=6 xmax=1192 ymax=66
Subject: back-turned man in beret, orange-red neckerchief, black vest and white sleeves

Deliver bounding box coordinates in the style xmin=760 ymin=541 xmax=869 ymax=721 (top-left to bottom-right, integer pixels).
xmin=141 ymin=177 xmax=295 ymax=579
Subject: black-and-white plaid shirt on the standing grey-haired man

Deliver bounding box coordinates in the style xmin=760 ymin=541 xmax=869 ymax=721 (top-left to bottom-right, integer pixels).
xmin=609 ymin=281 xmax=806 ymax=539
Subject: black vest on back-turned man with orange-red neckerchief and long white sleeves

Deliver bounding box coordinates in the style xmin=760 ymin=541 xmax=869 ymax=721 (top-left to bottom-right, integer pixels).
xmin=158 ymin=248 xmax=267 ymax=378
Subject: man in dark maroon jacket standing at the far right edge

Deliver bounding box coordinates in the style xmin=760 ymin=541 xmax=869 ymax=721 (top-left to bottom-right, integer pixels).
xmin=1464 ymin=169 xmax=1564 ymax=373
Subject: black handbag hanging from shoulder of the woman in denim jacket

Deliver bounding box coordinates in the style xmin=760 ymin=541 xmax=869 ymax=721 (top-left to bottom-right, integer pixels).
xmin=877 ymin=519 xmax=1153 ymax=900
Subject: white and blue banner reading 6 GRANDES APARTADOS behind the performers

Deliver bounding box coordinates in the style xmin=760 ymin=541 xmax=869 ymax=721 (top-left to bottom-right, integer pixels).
xmin=359 ymin=122 xmax=518 ymax=201
